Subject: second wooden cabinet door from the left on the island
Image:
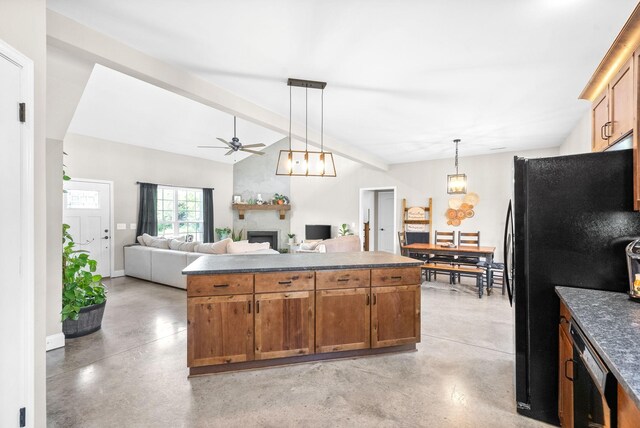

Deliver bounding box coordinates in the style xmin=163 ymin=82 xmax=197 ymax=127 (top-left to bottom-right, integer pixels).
xmin=255 ymin=291 xmax=314 ymax=360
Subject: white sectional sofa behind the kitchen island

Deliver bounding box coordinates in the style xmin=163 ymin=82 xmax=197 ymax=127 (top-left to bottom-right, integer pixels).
xmin=124 ymin=236 xmax=279 ymax=290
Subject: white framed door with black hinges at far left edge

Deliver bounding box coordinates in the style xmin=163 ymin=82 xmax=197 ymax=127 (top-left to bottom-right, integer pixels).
xmin=0 ymin=40 xmax=35 ymax=427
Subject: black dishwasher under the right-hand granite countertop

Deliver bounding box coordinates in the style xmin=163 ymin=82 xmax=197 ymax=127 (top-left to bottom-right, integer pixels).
xmin=570 ymin=322 xmax=618 ymax=428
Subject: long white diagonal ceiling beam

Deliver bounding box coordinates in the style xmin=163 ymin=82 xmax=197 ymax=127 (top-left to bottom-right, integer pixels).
xmin=47 ymin=10 xmax=389 ymax=171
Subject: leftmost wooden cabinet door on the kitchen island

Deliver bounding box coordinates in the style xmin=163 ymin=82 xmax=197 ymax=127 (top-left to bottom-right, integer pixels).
xmin=187 ymin=294 xmax=253 ymax=367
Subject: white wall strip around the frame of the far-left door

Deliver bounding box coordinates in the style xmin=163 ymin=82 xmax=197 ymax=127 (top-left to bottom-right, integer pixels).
xmin=0 ymin=0 xmax=47 ymax=427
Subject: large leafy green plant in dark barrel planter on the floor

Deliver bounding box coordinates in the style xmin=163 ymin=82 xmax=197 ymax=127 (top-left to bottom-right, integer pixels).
xmin=61 ymin=224 xmax=107 ymax=338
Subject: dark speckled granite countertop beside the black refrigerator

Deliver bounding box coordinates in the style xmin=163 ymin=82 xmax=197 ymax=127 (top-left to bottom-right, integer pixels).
xmin=556 ymin=287 xmax=640 ymax=407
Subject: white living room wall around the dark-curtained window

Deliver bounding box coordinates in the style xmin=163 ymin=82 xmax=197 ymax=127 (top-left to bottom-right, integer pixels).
xmin=64 ymin=134 xmax=233 ymax=270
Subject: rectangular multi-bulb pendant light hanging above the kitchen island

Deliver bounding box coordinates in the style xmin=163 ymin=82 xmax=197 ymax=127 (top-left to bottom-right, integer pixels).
xmin=276 ymin=78 xmax=336 ymax=177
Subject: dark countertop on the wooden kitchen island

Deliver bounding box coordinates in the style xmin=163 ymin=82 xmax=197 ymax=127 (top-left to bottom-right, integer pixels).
xmin=182 ymin=251 xmax=423 ymax=275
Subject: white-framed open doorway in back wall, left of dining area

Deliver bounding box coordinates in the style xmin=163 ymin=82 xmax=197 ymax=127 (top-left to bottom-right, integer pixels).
xmin=360 ymin=186 xmax=398 ymax=253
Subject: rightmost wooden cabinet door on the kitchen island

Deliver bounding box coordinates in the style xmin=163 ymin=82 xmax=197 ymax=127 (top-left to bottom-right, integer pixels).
xmin=371 ymin=285 xmax=420 ymax=348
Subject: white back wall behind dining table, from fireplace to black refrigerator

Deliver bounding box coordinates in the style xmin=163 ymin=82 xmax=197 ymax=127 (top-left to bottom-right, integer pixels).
xmin=291 ymin=148 xmax=558 ymax=260
